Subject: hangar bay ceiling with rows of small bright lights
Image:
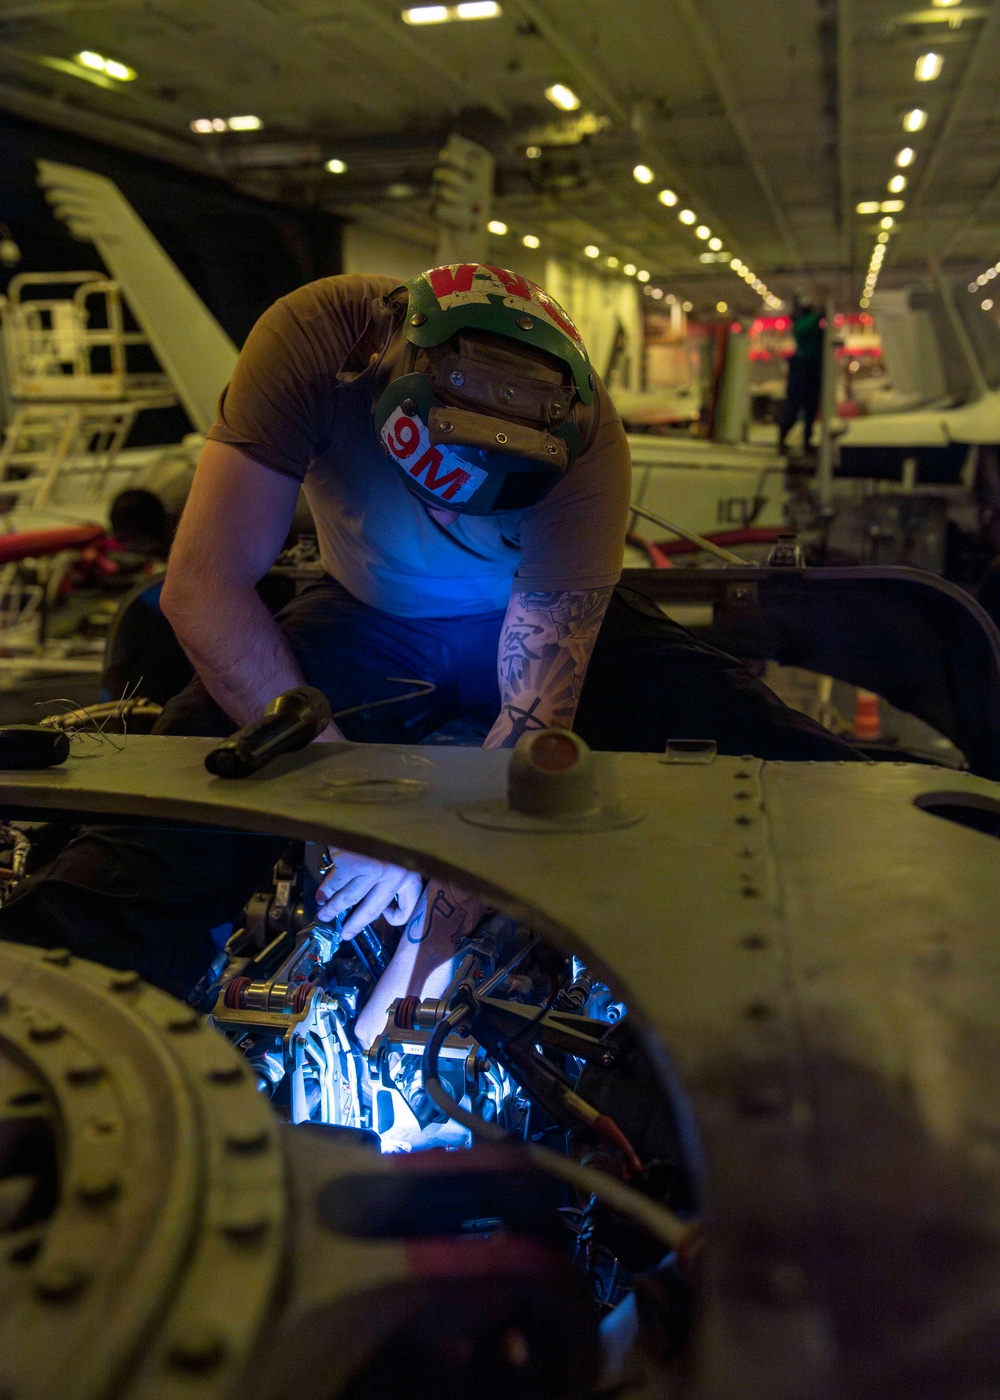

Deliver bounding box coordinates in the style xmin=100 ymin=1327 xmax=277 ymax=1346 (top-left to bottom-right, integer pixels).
xmin=0 ymin=0 xmax=1000 ymax=311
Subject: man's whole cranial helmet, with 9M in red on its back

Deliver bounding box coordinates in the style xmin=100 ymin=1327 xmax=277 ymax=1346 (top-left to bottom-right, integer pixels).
xmin=374 ymin=263 xmax=595 ymax=515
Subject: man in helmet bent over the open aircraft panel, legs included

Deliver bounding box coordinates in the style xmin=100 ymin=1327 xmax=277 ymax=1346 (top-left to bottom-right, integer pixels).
xmin=0 ymin=263 xmax=850 ymax=1042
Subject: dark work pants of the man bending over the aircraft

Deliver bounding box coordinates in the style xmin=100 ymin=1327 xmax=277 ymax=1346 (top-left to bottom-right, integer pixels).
xmin=0 ymin=580 xmax=857 ymax=995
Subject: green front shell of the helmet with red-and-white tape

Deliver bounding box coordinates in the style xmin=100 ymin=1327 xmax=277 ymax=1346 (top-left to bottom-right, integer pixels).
xmin=403 ymin=263 xmax=594 ymax=403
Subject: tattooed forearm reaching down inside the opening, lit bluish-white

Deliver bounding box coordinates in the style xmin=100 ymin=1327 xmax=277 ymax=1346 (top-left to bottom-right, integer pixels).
xmin=354 ymin=881 xmax=489 ymax=1050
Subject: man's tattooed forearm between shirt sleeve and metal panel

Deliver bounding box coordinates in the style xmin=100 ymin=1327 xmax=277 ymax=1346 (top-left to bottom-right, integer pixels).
xmin=483 ymin=588 xmax=613 ymax=749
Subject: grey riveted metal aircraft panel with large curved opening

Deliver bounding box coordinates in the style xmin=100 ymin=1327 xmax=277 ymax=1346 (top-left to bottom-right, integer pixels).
xmin=0 ymin=738 xmax=1000 ymax=1400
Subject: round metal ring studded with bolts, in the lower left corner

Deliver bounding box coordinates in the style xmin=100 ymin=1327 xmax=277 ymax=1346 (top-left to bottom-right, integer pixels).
xmin=0 ymin=944 xmax=286 ymax=1400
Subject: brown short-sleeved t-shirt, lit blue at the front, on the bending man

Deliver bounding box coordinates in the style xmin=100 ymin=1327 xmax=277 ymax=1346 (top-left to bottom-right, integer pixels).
xmin=209 ymin=276 xmax=630 ymax=617
